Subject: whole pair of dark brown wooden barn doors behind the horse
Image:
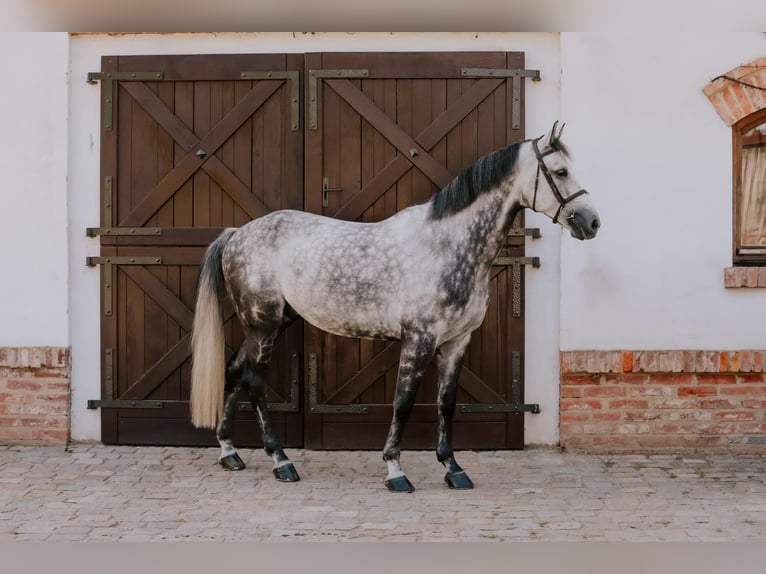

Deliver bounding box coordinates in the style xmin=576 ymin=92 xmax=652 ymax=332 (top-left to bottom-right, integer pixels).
xmin=91 ymin=52 xmax=536 ymax=449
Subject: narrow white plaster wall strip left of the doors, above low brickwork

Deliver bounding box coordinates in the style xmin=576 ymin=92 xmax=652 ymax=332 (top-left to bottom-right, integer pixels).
xmin=0 ymin=32 xmax=69 ymax=347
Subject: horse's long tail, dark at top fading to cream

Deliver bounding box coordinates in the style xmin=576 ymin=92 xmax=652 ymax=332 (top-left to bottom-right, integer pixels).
xmin=190 ymin=229 xmax=236 ymax=428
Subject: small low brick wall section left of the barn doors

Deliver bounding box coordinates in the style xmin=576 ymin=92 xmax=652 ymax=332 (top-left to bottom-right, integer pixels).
xmin=0 ymin=347 xmax=70 ymax=444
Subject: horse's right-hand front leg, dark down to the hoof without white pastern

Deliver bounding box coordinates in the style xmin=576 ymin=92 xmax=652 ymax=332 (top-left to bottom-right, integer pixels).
xmin=436 ymin=333 xmax=473 ymax=490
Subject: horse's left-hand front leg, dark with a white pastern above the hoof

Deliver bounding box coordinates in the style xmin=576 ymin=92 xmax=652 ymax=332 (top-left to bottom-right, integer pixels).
xmin=383 ymin=334 xmax=435 ymax=492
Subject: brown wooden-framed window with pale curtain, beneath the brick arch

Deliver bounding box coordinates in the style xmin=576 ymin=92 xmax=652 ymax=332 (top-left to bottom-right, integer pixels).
xmin=732 ymin=109 xmax=766 ymax=265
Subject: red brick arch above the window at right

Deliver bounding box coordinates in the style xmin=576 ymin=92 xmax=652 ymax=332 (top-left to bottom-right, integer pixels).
xmin=703 ymin=57 xmax=766 ymax=126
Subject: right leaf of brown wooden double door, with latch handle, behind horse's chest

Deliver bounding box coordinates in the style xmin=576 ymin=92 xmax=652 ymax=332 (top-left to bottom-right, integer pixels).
xmin=304 ymin=52 xmax=529 ymax=449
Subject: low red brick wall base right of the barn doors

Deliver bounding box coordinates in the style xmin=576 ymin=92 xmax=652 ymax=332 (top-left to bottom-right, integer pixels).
xmin=560 ymin=351 xmax=766 ymax=450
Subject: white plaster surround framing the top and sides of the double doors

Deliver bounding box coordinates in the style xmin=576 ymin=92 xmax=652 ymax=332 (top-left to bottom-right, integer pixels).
xmin=69 ymin=32 xmax=560 ymax=444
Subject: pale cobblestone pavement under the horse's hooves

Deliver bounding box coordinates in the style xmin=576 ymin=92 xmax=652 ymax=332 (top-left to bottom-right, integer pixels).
xmin=0 ymin=444 xmax=766 ymax=541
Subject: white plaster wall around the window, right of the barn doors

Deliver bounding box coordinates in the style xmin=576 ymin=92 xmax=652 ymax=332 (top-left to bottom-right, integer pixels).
xmin=561 ymin=35 xmax=766 ymax=356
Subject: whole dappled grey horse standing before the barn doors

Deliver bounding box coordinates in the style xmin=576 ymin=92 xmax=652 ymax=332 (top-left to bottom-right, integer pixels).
xmin=191 ymin=122 xmax=600 ymax=492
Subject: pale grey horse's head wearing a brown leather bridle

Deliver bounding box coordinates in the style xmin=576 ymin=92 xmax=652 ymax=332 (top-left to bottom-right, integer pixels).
xmin=522 ymin=122 xmax=601 ymax=239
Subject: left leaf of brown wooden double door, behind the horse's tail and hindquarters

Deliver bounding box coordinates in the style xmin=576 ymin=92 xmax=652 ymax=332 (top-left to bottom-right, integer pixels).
xmin=89 ymin=54 xmax=303 ymax=446
